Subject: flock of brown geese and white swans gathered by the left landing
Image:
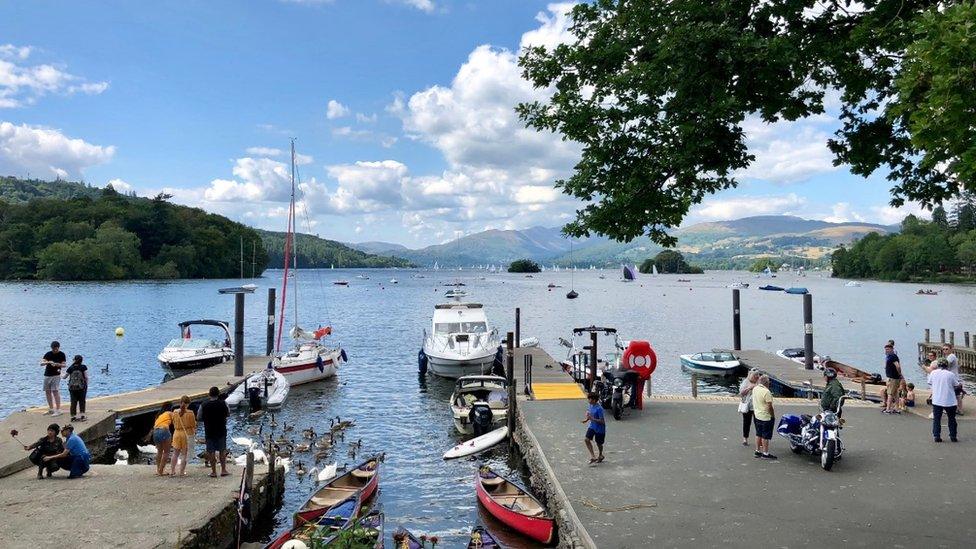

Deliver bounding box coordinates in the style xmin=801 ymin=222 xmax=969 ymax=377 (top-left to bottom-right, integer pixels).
xmin=115 ymin=414 xmax=363 ymax=483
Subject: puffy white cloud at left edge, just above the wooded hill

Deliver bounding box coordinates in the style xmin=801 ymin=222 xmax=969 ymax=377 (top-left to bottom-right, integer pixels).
xmin=0 ymin=122 xmax=115 ymax=178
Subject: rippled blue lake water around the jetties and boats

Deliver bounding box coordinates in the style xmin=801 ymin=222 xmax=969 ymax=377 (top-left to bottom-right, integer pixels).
xmin=0 ymin=270 xmax=976 ymax=547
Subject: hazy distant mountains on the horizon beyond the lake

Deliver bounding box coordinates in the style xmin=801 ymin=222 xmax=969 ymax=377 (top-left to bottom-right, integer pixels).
xmin=350 ymin=215 xmax=898 ymax=268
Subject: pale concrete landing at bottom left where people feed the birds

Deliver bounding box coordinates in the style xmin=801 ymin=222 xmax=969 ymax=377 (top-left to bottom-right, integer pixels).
xmin=0 ymin=464 xmax=250 ymax=548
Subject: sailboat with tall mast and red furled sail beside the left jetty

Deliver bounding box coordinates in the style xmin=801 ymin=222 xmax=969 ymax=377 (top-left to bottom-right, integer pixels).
xmin=271 ymin=140 xmax=346 ymax=386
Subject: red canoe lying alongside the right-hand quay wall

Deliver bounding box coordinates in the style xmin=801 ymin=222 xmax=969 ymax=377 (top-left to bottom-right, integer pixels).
xmin=474 ymin=467 xmax=556 ymax=543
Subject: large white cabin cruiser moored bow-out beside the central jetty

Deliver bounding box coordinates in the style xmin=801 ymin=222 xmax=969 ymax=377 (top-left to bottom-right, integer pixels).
xmin=424 ymin=302 xmax=499 ymax=379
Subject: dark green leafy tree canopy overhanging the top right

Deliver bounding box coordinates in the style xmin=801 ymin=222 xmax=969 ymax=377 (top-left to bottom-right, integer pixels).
xmin=517 ymin=0 xmax=976 ymax=245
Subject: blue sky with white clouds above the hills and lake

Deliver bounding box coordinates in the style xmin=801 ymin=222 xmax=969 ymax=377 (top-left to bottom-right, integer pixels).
xmin=0 ymin=0 xmax=932 ymax=247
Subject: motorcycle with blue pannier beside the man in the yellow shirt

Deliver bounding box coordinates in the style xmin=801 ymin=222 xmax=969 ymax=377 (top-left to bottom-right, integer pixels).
xmin=776 ymin=396 xmax=847 ymax=471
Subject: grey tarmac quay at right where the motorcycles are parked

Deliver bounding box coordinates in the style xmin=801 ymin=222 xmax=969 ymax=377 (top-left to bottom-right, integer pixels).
xmin=519 ymin=397 xmax=976 ymax=549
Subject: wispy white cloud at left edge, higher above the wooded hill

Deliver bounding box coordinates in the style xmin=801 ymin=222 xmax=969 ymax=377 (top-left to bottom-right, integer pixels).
xmin=0 ymin=44 xmax=108 ymax=108
